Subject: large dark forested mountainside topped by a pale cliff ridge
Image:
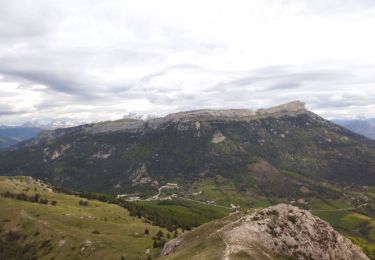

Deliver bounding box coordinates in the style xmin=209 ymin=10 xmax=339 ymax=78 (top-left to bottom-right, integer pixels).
xmin=0 ymin=101 xmax=375 ymax=207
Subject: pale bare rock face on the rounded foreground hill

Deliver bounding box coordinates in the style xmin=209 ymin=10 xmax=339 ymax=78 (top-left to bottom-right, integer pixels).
xmin=222 ymin=204 xmax=368 ymax=260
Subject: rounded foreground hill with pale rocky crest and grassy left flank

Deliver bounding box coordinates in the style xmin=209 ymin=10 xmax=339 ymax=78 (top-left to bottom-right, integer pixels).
xmin=162 ymin=204 xmax=368 ymax=260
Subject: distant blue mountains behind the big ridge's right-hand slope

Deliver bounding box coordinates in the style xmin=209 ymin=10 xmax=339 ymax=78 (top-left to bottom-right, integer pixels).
xmin=332 ymin=118 xmax=375 ymax=140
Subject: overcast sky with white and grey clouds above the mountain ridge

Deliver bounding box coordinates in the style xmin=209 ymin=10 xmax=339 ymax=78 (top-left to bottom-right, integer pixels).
xmin=0 ymin=0 xmax=375 ymax=124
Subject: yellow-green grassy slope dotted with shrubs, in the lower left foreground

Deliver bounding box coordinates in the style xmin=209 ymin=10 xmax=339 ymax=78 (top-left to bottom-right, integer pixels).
xmin=0 ymin=177 xmax=166 ymax=259
